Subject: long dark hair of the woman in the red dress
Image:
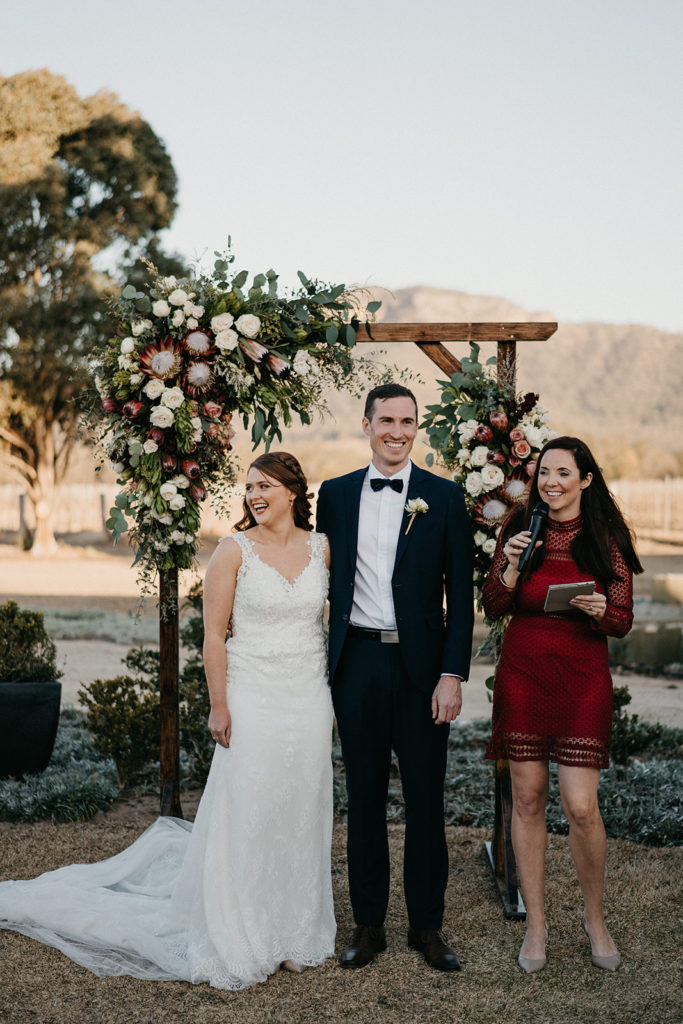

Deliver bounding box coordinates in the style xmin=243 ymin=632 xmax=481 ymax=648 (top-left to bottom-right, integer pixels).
xmin=504 ymin=437 xmax=643 ymax=587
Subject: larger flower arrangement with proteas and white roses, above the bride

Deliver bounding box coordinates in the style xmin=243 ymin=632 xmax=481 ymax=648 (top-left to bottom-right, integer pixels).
xmin=89 ymin=250 xmax=382 ymax=581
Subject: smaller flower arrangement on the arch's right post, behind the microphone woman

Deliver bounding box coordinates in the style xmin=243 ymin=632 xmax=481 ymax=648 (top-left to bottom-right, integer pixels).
xmin=423 ymin=344 xmax=557 ymax=606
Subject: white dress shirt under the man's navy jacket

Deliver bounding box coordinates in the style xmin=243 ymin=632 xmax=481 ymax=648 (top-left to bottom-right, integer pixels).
xmin=350 ymin=462 xmax=413 ymax=630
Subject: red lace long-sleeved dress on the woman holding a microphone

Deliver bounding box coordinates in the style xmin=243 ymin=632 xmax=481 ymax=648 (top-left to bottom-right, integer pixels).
xmin=483 ymin=516 xmax=633 ymax=768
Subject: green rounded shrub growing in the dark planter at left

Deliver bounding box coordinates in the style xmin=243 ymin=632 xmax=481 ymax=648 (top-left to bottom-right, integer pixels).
xmin=0 ymin=601 xmax=62 ymax=683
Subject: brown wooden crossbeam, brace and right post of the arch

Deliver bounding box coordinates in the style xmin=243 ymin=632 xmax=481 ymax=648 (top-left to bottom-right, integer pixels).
xmin=357 ymin=323 xmax=557 ymax=919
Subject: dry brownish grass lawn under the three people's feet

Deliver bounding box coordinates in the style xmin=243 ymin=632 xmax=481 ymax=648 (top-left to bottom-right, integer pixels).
xmin=0 ymin=820 xmax=683 ymax=1024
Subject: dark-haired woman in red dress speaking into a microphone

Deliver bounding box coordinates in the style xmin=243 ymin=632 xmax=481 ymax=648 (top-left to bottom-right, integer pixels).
xmin=483 ymin=437 xmax=643 ymax=972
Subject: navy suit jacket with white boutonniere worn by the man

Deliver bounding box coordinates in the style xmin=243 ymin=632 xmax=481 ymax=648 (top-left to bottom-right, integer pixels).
xmin=317 ymin=466 xmax=474 ymax=693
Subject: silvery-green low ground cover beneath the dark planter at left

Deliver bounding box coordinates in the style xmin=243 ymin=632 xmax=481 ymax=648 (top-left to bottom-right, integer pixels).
xmin=0 ymin=711 xmax=119 ymax=821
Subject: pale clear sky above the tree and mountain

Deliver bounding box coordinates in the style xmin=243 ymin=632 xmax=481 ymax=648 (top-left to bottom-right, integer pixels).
xmin=0 ymin=0 xmax=683 ymax=331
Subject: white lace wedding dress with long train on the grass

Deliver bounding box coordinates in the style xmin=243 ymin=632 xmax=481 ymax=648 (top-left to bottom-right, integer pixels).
xmin=0 ymin=534 xmax=336 ymax=989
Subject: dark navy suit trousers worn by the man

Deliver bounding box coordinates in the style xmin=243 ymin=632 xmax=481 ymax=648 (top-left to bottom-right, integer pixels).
xmin=332 ymin=636 xmax=450 ymax=929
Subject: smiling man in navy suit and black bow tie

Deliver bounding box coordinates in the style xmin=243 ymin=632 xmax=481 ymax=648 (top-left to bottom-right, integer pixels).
xmin=317 ymin=384 xmax=473 ymax=971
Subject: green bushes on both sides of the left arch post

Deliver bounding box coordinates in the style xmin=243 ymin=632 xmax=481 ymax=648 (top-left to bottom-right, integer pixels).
xmin=79 ymin=584 xmax=215 ymax=785
